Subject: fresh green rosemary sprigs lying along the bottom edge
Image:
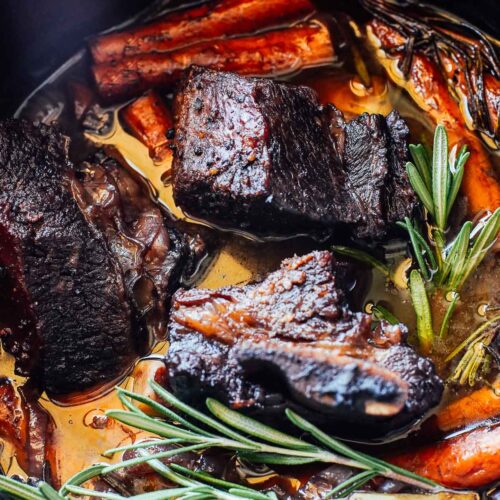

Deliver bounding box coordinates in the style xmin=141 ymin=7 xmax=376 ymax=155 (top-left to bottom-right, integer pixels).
xmin=0 ymin=381 xmax=440 ymax=500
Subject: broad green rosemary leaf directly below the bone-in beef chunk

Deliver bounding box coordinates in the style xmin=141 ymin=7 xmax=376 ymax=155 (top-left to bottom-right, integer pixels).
xmin=206 ymin=398 xmax=319 ymax=452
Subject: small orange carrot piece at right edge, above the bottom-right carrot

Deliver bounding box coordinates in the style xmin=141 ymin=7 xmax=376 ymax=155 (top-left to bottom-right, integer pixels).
xmin=434 ymin=382 xmax=500 ymax=434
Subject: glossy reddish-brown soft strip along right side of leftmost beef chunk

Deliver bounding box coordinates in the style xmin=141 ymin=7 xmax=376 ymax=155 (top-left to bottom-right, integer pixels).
xmin=72 ymin=158 xmax=187 ymax=348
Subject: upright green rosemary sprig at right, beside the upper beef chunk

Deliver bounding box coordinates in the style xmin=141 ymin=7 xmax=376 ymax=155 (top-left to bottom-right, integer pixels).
xmin=333 ymin=125 xmax=500 ymax=364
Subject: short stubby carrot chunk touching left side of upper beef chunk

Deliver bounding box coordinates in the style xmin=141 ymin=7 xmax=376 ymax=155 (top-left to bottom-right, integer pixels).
xmin=122 ymin=90 xmax=174 ymax=161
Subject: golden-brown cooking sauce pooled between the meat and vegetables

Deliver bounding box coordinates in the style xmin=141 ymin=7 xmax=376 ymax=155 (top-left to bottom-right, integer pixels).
xmin=0 ymin=0 xmax=500 ymax=490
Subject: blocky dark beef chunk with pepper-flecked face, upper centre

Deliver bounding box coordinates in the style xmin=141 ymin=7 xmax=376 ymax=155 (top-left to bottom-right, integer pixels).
xmin=173 ymin=68 xmax=416 ymax=238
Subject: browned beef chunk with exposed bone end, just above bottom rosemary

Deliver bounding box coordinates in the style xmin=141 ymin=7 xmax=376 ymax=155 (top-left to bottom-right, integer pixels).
xmin=166 ymin=251 xmax=443 ymax=433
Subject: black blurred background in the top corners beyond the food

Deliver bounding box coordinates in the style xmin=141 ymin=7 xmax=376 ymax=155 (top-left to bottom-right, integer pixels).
xmin=0 ymin=0 xmax=500 ymax=116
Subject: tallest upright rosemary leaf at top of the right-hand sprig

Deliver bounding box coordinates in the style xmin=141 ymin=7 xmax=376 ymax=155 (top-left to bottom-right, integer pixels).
xmin=432 ymin=125 xmax=449 ymax=231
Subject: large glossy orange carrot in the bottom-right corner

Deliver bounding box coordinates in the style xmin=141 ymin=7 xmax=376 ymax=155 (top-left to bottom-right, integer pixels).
xmin=387 ymin=423 xmax=500 ymax=488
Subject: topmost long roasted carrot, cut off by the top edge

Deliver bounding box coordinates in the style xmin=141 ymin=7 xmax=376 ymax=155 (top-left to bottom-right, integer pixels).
xmin=90 ymin=0 xmax=314 ymax=64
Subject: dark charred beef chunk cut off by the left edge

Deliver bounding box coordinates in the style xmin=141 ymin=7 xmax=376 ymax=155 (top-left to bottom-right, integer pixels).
xmin=0 ymin=120 xmax=135 ymax=393
